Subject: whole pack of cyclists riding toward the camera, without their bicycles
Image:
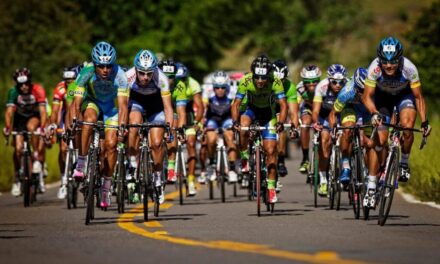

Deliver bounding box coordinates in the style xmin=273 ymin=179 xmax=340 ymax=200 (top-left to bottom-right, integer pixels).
xmin=3 ymin=37 xmax=431 ymax=212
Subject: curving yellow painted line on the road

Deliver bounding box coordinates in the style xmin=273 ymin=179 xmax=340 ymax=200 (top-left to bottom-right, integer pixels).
xmin=118 ymin=191 xmax=365 ymax=264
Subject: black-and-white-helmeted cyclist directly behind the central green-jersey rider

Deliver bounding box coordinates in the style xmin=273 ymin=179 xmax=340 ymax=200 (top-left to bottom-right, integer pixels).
xmin=272 ymin=60 xmax=299 ymax=180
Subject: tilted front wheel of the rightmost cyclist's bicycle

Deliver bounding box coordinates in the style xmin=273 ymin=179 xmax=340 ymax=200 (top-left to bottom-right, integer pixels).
xmin=378 ymin=151 xmax=399 ymax=226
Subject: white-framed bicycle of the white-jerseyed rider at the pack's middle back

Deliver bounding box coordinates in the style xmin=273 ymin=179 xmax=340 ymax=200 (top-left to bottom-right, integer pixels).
xmin=206 ymin=128 xmax=237 ymax=203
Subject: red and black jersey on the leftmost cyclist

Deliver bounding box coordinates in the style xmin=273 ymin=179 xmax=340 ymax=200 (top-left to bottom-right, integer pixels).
xmin=6 ymin=83 xmax=47 ymax=117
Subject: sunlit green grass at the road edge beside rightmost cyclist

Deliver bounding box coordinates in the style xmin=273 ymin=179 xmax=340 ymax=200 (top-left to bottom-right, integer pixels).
xmin=400 ymin=112 xmax=440 ymax=203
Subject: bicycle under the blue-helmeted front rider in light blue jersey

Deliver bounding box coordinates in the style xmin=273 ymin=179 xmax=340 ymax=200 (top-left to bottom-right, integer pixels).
xmin=78 ymin=121 xmax=119 ymax=225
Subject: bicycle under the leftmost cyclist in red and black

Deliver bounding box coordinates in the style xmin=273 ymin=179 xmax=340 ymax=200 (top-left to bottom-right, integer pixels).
xmin=5 ymin=131 xmax=41 ymax=207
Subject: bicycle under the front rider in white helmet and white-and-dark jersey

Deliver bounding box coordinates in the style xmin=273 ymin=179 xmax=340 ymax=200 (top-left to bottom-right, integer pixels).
xmin=128 ymin=123 xmax=169 ymax=221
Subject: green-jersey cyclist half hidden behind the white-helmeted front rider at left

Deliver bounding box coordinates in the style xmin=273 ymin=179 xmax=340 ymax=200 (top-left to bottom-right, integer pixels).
xmin=159 ymin=59 xmax=188 ymax=188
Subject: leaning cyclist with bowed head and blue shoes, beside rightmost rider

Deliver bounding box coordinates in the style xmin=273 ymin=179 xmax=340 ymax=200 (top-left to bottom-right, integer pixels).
xmin=328 ymin=67 xmax=371 ymax=187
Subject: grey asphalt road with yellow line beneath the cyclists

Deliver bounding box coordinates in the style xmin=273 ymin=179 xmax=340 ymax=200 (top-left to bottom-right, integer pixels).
xmin=0 ymin=146 xmax=440 ymax=263
